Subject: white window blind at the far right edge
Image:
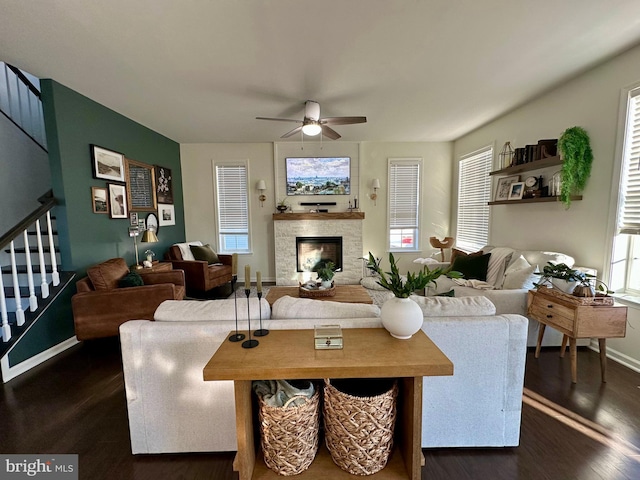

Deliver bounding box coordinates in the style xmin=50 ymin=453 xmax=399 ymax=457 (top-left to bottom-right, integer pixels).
xmin=618 ymin=89 xmax=640 ymax=235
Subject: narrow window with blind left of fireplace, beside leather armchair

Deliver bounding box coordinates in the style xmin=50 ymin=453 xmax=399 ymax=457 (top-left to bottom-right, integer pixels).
xmin=215 ymin=162 xmax=250 ymax=253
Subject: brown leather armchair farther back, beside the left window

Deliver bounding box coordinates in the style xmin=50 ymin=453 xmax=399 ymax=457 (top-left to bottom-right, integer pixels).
xmin=165 ymin=245 xmax=236 ymax=297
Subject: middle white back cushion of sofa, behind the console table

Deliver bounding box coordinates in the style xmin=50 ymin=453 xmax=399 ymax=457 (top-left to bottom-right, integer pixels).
xmin=271 ymin=295 xmax=380 ymax=319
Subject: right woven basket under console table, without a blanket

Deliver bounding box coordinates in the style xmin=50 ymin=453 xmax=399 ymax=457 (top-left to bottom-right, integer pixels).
xmin=324 ymin=379 xmax=398 ymax=475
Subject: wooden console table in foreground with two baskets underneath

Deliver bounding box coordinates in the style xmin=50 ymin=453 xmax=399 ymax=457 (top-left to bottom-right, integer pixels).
xmin=203 ymin=328 xmax=453 ymax=480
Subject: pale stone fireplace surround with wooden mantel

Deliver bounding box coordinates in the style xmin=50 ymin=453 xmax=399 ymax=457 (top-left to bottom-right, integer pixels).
xmin=273 ymin=212 xmax=364 ymax=286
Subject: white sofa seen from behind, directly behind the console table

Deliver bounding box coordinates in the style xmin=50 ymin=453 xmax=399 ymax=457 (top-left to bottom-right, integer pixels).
xmin=120 ymin=297 xmax=527 ymax=454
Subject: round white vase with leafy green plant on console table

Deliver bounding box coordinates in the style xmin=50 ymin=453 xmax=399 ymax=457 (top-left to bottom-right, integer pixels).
xmin=367 ymin=252 xmax=462 ymax=339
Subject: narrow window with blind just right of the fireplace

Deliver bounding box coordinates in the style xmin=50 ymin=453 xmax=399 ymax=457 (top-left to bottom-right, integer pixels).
xmin=388 ymin=158 xmax=422 ymax=251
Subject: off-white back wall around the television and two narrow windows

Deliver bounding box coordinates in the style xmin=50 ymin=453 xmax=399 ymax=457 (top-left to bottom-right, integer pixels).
xmin=180 ymin=142 xmax=452 ymax=281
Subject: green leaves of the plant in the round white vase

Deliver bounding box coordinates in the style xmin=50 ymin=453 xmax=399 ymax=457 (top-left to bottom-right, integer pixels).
xmin=367 ymin=252 xmax=462 ymax=298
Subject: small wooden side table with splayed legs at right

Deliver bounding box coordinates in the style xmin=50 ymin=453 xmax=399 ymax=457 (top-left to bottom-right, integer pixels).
xmin=527 ymin=288 xmax=627 ymax=383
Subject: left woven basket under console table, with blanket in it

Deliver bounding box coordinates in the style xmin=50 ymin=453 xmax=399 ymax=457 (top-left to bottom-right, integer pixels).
xmin=258 ymin=390 xmax=320 ymax=476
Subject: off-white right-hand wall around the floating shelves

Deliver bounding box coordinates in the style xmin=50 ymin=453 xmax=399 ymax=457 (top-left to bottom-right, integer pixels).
xmin=452 ymin=43 xmax=640 ymax=369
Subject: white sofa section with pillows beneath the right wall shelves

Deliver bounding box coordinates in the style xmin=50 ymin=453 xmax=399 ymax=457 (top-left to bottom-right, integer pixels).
xmin=425 ymin=245 xmax=575 ymax=347
